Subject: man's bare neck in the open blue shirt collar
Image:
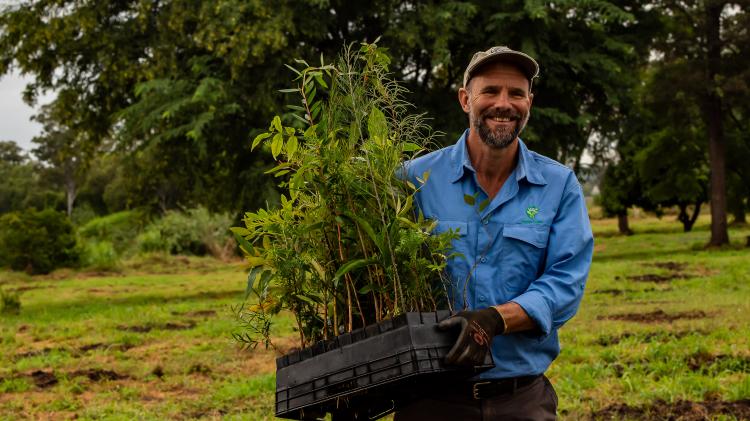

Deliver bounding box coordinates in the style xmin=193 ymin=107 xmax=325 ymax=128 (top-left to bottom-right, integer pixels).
xmin=466 ymin=129 xmax=518 ymax=199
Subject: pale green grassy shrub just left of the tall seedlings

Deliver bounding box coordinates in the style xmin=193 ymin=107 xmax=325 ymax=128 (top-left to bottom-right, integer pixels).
xmin=137 ymin=207 xmax=234 ymax=259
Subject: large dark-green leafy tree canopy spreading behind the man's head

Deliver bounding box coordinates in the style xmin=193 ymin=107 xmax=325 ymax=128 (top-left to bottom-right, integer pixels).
xmin=0 ymin=0 xmax=652 ymax=217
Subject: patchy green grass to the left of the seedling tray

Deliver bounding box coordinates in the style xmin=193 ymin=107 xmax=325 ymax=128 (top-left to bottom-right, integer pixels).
xmin=0 ymin=256 xmax=292 ymax=419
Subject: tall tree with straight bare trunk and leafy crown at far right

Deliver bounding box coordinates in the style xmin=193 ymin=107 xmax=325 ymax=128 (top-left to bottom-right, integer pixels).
xmin=653 ymin=0 xmax=750 ymax=246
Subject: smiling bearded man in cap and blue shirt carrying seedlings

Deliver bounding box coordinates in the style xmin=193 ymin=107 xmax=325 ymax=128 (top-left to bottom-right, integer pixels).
xmin=395 ymin=47 xmax=593 ymax=421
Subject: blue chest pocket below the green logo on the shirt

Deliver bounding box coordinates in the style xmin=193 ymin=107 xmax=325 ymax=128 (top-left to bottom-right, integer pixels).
xmin=502 ymin=224 xmax=550 ymax=300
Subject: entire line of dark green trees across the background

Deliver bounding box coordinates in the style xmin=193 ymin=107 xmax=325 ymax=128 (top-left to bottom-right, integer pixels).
xmin=0 ymin=0 xmax=750 ymax=244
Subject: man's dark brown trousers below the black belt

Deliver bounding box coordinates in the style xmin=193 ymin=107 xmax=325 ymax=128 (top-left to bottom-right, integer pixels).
xmin=394 ymin=376 xmax=557 ymax=421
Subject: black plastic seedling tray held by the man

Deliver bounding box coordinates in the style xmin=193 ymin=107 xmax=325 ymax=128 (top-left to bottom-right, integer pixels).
xmin=276 ymin=310 xmax=494 ymax=420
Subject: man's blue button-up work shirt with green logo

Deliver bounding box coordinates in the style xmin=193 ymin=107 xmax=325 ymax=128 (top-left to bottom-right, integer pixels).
xmin=406 ymin=130 xmax=594 ymax=378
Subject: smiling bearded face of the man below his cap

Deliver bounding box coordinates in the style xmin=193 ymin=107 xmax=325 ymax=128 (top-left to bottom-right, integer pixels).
xmin=458 ymin=63 xmax=534 ymax=149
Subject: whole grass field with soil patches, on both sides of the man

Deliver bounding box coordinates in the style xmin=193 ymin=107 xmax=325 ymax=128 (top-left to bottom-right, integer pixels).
xmin=0 ymin=218 xmax=750 ymax=420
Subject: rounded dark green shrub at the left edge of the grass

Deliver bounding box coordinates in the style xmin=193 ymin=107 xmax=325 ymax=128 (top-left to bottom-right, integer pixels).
xmin=0 ymin=209 xmax=79 ymax=273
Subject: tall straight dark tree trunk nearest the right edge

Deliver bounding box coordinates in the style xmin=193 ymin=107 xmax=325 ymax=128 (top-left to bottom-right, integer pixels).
xmin=704 ymin=1 xmax=729 ymax=246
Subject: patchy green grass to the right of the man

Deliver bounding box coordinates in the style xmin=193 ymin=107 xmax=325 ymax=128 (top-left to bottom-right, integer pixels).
xmin=548 ymin=218 xmax=750 ymax=419
